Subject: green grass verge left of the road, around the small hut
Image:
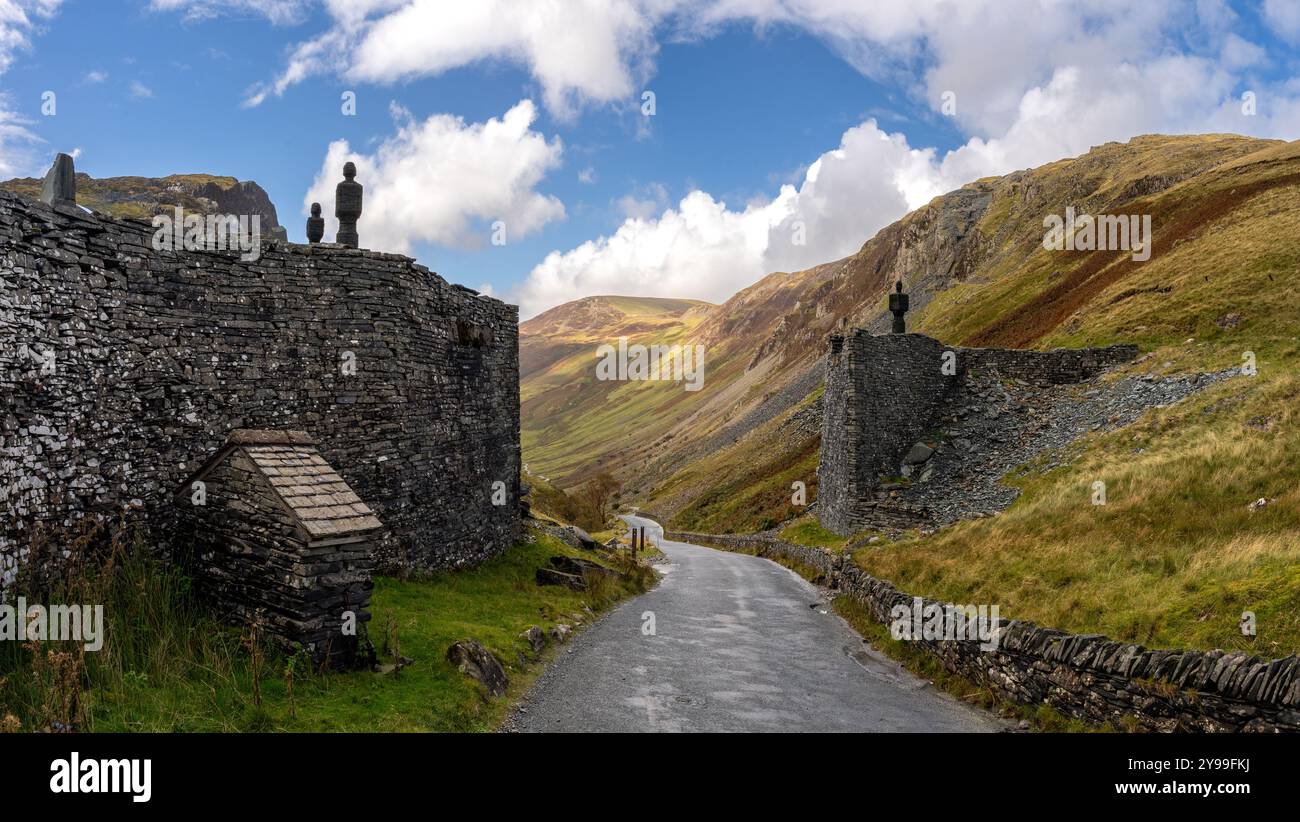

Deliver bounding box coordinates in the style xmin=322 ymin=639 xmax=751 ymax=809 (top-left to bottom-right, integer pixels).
xmin=0 ymin=522 xmax=654 ymax=732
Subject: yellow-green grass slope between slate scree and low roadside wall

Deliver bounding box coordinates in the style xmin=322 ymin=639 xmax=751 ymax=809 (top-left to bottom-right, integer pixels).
xmin=855 ymin=366 xmax=1300 ymax=656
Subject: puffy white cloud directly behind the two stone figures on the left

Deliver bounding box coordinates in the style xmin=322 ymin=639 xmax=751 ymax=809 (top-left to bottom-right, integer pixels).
xmin=303 ymin=100 xmax=564 ymax=252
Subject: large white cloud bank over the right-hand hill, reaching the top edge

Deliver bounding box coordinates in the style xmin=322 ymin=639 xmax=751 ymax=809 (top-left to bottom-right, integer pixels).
xmin=514 ymin=0 xmax=1300 ymax=316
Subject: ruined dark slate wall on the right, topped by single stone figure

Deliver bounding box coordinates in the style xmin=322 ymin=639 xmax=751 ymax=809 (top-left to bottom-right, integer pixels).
xmin=818 ymin=329 xmax=1138 ymax=535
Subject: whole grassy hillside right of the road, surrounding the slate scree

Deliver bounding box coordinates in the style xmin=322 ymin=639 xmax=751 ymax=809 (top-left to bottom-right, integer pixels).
xmin=522 ymin=135 xmax=1300 ymax=656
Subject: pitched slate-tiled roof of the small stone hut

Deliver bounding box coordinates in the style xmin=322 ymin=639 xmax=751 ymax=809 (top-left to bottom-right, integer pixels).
xmin=186 ymin=428 xmax=384 ymax=540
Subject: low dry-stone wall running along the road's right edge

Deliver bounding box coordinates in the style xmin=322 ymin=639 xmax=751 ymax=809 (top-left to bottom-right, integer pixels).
xmin=664 ymin=531 xmax=1300 ymax=732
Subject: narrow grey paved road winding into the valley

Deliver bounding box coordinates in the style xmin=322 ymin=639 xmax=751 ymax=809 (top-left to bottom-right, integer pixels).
xmin=510 ymin=518 xmax=1002 ymax=731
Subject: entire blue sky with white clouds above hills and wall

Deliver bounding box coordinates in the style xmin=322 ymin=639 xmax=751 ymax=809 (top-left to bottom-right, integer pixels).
xmin=0 ymin=0 xmax=1300 ymax=316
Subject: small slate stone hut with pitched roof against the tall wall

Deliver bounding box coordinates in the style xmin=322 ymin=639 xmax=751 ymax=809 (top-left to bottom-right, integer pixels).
xmin=173 ymin=429 xmax=384 ymax=666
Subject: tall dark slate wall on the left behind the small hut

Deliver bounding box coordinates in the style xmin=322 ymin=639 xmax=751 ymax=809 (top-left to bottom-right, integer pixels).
xmin=0 ymin=192 xmax=520 ymax=577
